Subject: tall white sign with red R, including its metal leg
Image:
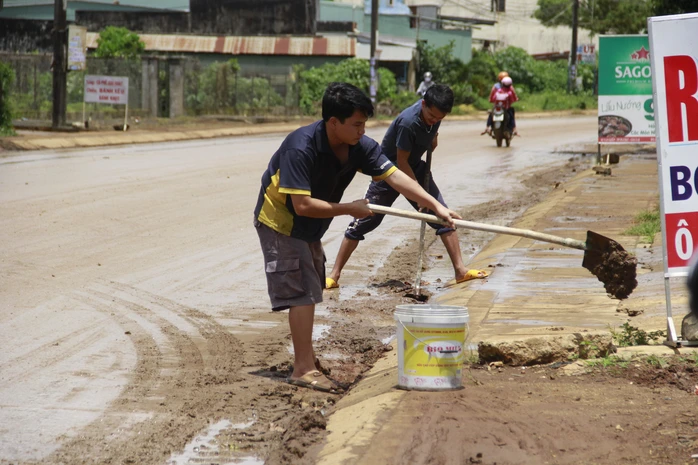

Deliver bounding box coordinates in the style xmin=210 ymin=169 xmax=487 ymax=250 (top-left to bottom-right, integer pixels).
xmin=647 ymin=13 xmax=698 ymax=347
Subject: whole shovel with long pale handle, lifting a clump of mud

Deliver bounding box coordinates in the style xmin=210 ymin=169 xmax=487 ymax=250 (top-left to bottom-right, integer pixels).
xmin=368 ymin=204 xmax=637 ymax=299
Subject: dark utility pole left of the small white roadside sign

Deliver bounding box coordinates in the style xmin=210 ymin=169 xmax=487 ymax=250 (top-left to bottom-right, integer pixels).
xmin=52 ymin=0 xmax=68 ymax=129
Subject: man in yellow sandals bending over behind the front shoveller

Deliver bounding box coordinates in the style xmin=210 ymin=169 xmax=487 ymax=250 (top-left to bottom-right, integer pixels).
xmin=325 ymin=84 xmax=487 ymax=289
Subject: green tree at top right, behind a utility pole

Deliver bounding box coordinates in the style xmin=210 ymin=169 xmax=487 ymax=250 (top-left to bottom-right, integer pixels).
xmin=533 ymin=0 xmax=652 ymax=34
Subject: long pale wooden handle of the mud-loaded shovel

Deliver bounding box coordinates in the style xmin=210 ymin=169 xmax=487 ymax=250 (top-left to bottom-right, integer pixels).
xmin=368 ymin=204 xmax=587 ymax=250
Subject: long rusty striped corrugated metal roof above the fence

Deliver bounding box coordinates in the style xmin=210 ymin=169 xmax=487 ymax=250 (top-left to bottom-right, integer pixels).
xmin=87 ymin=32 xmax=356 ymax=57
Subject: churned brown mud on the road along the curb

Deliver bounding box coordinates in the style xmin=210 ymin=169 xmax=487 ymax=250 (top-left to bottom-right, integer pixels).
xmin=3 ymin=153 xmax=588 ymax=464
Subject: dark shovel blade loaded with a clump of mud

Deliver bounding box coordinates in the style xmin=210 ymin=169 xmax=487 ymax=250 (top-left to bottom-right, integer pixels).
xmin=582 ymin=231 xmax=637 ymax=299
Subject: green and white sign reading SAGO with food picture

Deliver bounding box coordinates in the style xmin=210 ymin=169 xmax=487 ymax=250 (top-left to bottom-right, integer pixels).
xmin=598 ymin=35 xmax=655 ymax=144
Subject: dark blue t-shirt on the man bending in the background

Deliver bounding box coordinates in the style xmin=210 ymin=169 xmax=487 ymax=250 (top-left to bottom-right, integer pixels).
xmin=381 ymin=99 xmax=441 ymax=169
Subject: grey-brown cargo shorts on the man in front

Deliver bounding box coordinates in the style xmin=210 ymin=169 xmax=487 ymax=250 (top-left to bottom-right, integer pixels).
xmin=254 ymin=220 xmax=325 ymax=311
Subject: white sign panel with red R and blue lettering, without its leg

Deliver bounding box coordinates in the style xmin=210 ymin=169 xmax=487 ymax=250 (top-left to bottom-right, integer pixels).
xmin=648 ymin=13 xmax=698 ymax=276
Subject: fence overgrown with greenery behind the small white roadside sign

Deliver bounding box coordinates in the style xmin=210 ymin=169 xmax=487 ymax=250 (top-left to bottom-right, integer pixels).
xmin=0 ymin=54 xmax=300 ymax=121
